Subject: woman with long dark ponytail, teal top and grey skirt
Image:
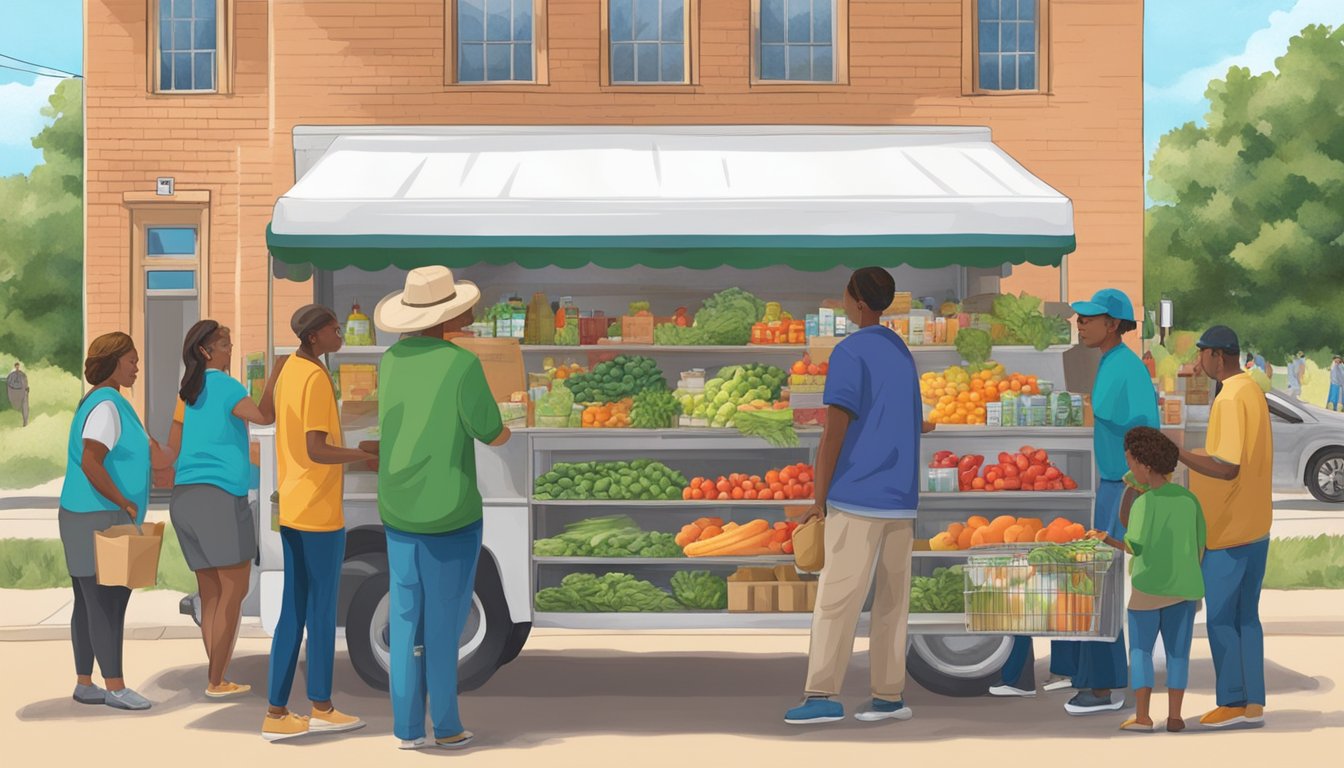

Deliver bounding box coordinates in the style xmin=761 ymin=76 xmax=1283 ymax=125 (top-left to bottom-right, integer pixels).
xmin=168 ymin=320 xmax=284 ymax=698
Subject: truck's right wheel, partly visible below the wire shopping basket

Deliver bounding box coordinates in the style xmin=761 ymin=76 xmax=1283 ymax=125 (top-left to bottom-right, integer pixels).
xmin=906 ymin=635 xmax=1012 ymax=697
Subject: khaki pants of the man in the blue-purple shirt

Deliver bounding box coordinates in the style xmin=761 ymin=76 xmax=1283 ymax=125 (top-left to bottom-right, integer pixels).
xmin=806 ymin=507 xmax=915 ymax=701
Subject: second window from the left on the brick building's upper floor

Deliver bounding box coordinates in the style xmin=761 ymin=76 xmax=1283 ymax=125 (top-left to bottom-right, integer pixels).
xmin=454 ymin=0 xmax=539 ymax=83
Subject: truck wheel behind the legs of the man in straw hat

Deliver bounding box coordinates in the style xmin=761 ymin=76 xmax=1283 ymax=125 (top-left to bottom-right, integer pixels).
xmin=345 ymin=553 xmax=513 ymax=691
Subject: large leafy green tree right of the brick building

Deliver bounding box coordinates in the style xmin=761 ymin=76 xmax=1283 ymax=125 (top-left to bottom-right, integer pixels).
xmin=1144 ymin=26 xmax=1344 ymax=359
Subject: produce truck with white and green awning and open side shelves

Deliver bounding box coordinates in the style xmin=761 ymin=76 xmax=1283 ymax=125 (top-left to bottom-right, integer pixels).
xmin=220 ymin=126 xmax=1118 ymax=695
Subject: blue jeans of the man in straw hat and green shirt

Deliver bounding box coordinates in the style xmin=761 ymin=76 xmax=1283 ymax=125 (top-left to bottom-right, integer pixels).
xmin=386 ymin=521 xmax=481 ymax=741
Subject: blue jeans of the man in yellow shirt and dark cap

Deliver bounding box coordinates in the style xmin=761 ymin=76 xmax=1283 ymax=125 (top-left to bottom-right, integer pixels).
xmin=1203 ymin=538 xmax=1269 ymax=706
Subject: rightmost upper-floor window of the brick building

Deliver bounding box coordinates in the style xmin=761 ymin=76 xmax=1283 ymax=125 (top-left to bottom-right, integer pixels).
xmin=970 ymin=0 xmax=1050 ymax=93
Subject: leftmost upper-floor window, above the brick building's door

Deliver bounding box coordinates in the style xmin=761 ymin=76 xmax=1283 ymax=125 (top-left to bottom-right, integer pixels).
xmin=151 ymin=0 xmax=228 ymax=93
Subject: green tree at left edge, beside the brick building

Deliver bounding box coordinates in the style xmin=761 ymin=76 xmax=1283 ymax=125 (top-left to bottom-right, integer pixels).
xmin=0 ymin=79 xmax=83 ymax=375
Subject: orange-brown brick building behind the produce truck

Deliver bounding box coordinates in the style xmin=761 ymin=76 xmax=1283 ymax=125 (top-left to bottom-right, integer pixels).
xmin=85 ymin=0 xmax=1144 ymax=438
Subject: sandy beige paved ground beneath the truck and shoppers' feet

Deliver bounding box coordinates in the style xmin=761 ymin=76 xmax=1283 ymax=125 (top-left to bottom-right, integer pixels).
xmin=0 ymin=633 xmax=1344 ymax=768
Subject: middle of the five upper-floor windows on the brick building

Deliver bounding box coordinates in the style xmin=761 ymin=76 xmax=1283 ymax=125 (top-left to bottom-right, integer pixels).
xmin=603 ymin=0 xmax=695 ymax=85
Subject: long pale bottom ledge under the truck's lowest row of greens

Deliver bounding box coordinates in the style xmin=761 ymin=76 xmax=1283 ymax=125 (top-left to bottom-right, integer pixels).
xmin=532 ymin=611 xmax=966 ymax=635
